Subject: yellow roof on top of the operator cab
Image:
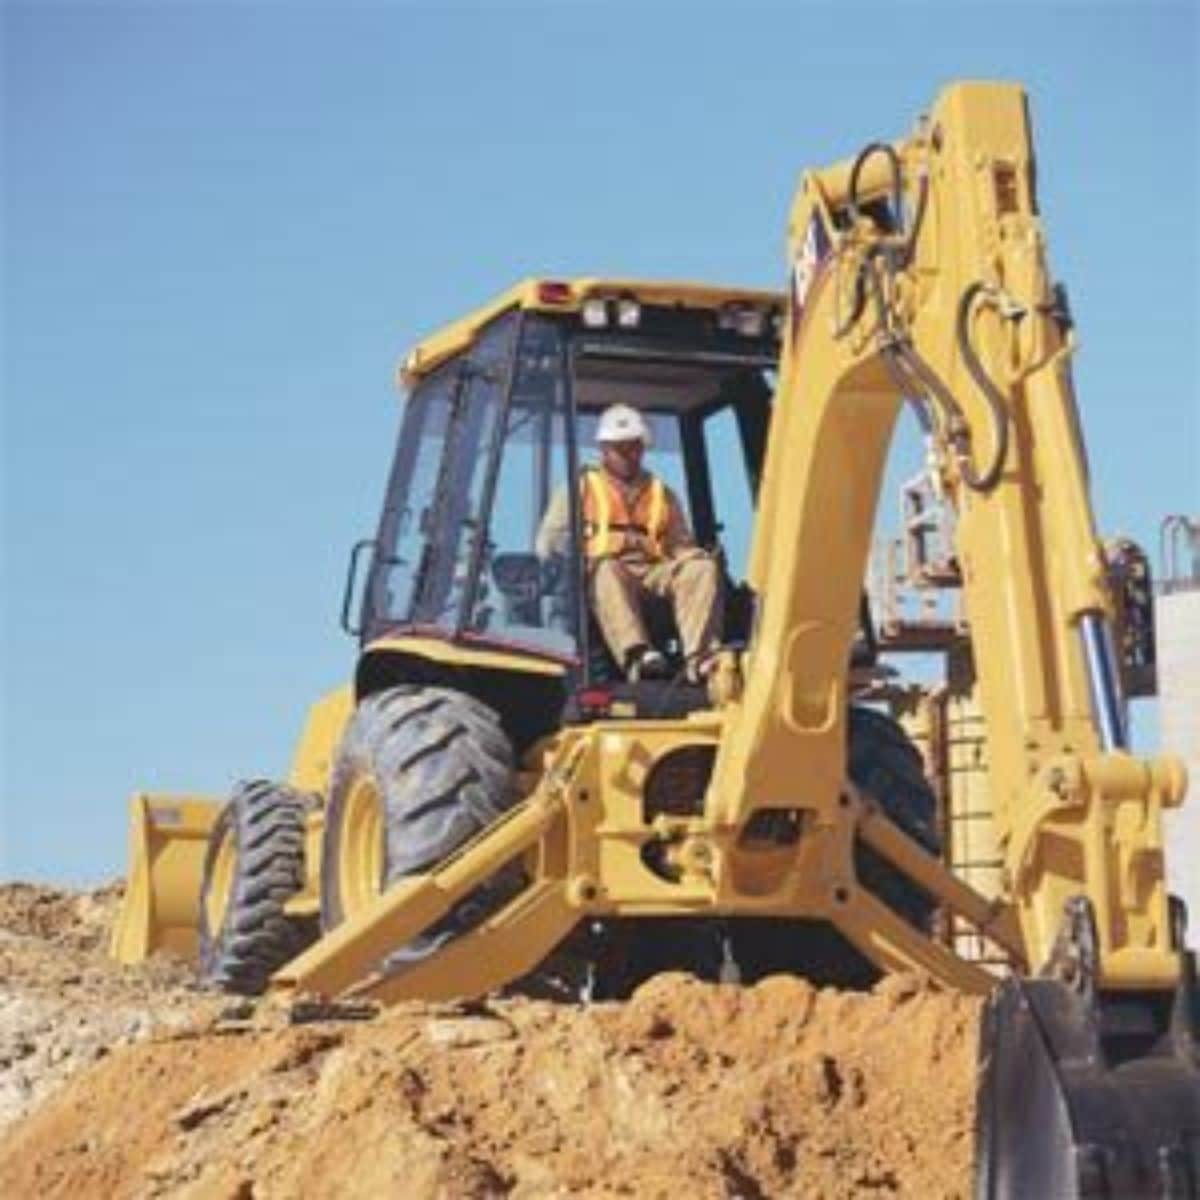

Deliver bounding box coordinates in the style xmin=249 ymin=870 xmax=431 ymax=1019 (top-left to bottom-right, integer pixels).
xmin=396 ymin=276 xmax=784 ymax=386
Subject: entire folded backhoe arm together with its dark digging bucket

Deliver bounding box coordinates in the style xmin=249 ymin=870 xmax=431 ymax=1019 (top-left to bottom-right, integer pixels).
xmin=709 ymin=84 xmax=1200 ymax=1200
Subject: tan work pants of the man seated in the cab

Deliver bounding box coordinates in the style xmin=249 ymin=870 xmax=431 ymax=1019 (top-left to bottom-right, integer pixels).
xmin=588 ymin=550 xmax=725 ymax=668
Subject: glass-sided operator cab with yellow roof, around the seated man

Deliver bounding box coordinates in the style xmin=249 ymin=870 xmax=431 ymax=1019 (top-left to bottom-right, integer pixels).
xmin=352 ymin=281 xmax=782 ymax=692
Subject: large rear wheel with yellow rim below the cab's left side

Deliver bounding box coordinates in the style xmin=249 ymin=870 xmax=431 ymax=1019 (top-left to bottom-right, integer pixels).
xmin=320 ymin=684 xmax=521 ymax=966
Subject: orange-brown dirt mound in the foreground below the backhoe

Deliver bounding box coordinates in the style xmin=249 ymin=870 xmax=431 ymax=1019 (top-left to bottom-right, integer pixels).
xmin=0 ymin=896 xmax=978 ymax=1200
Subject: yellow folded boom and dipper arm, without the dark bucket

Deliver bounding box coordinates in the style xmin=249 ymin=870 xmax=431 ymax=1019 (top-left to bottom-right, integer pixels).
xmin=709 ymin=83 xmax=1184 ymax=989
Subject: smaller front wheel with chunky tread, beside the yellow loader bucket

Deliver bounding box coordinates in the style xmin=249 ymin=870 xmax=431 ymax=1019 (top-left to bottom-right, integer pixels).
xmin=198 ymin=780 xmax=317 ymax=996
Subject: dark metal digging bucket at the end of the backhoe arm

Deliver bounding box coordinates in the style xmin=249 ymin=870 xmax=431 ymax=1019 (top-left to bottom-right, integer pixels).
xmin=976 ymin=961 xmax=1200 ymax=1200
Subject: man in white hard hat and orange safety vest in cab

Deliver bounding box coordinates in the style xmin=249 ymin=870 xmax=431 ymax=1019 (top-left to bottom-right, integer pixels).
xmin=536 ymin=404 xmax=724 ymax=682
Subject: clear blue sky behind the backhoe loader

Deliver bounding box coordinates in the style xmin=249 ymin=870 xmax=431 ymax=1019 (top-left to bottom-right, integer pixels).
xmin=0 ymin=0 xmax=1200 ymax=882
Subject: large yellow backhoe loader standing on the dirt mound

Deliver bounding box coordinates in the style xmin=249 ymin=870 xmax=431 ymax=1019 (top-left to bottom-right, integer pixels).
xmin=114 ymin=83 xmax=1200 ymax=1198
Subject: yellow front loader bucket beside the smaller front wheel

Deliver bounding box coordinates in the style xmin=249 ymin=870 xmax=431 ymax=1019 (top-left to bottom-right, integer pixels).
xmin=109 ymin=792 xmax=223 ymax=964
